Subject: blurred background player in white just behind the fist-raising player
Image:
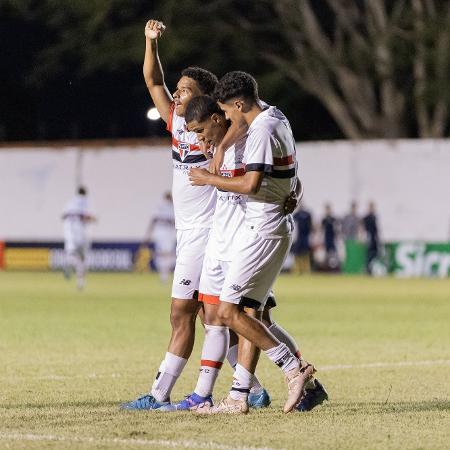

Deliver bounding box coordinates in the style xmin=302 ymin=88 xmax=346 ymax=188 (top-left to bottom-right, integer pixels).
xmin=143 ymin=192 xmax=177 ymax=283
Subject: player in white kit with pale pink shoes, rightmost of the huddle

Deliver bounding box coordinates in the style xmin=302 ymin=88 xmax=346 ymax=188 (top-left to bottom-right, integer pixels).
xmin=190 ymin=72 xmax=315 ymax=414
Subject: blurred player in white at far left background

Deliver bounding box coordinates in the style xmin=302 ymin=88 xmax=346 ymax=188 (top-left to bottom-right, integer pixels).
xmin=62 ymin=186 xmax=96 ymax=290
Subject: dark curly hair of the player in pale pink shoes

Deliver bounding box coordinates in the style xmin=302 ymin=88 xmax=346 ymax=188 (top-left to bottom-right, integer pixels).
xmin=214 ymin=70 xmax=258 ymax=103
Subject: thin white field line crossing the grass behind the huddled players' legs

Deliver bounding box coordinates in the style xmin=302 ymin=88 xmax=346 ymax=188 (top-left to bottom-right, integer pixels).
xmin=0 ymin=359 xmax=450 ymax=381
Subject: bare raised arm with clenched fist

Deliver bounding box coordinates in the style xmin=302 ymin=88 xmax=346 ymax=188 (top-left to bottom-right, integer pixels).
xmin=143 ymin=20 xmax=172 ymax=123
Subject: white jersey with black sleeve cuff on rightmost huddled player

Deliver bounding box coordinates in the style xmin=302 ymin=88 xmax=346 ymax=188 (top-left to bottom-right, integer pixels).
xmin=244 ymin=106 xmax=297 ymax=238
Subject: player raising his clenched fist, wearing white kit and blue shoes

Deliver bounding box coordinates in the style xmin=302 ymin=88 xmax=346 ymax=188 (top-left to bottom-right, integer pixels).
xmin=122 ymin=20 xmax=239 ymax=410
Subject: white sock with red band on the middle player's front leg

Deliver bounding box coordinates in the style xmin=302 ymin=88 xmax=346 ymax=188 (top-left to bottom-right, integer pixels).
xmin=194 ymin=324 xmax=230 ymax=397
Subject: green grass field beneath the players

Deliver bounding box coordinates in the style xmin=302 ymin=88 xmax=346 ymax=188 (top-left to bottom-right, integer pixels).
xmin=0 ymin=273 xmax=450 ymax=450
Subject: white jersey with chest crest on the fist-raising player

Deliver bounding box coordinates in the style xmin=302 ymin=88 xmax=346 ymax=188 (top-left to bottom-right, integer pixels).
xmin=167 ymin=103 xmax=216 ymax=230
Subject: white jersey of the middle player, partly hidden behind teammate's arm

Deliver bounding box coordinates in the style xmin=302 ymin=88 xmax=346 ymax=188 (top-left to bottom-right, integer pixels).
xmin=207 ymin=138 xmax=247 ymax=261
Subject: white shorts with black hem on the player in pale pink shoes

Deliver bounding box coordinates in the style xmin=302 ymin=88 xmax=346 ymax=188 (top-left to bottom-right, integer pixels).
xmin=220 ymin=230 xmax=292 ymax=311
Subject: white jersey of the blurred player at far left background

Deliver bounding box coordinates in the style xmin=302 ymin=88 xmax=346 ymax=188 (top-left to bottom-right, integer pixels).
xmin=63 ymin=195 xmax=93 ymax=245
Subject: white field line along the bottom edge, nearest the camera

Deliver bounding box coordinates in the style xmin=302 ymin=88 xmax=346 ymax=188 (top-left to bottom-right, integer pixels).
xmin=0 ymin=433 xmax=274 ymax=450
